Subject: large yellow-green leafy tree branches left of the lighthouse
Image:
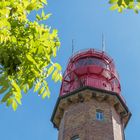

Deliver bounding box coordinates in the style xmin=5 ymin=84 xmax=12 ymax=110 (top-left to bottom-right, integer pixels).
xmin=0 ymin=0 xmax=62 ymax=110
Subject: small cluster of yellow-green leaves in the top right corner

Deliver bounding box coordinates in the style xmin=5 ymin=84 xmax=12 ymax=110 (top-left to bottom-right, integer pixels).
xmin=109 ymin=0 xmax=140 ymax=13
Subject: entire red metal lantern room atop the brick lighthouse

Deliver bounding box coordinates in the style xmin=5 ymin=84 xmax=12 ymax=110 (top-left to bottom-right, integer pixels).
xmin=60 ymin=49 xmax=121 ymax=96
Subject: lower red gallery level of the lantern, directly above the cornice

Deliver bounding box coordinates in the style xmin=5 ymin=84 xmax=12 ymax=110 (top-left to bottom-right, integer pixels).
xmin=60 ymin=65 xmax=121 ymax=95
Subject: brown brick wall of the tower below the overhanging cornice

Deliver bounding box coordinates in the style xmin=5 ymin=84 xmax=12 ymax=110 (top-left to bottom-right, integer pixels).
xmin=58 ymin=99 xmax=124 ymax=140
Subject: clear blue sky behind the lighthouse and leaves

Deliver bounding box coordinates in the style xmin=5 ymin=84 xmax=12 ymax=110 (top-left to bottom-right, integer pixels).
xmin=0 ymin=0 xmax=140 ymax=140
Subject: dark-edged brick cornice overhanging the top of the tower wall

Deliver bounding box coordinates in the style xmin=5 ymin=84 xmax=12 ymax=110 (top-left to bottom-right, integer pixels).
xmin=51 ymin=86 xmax=131 ymax=129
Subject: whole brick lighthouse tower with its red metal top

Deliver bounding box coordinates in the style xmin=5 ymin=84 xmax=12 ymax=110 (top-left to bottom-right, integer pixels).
xmin=51 ymin=49 xmax=131 ymax=140
